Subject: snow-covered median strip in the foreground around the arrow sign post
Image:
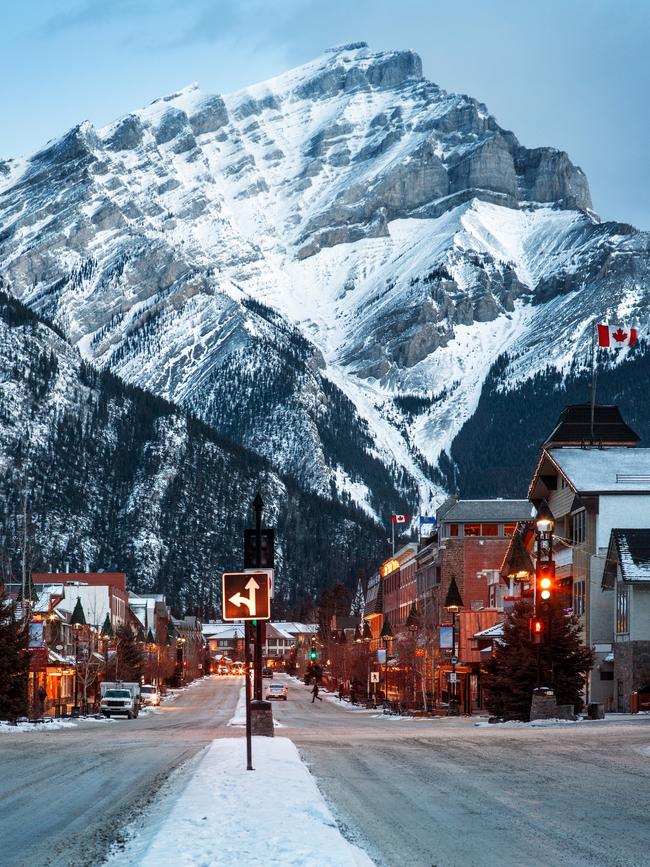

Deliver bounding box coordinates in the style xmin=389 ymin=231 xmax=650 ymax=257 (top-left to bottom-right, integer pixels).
xmin=112 ymin=737 xmax=373 ymax=867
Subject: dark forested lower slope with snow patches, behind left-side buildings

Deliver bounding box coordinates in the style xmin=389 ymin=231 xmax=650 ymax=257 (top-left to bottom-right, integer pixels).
xmin=0 ymin=283 xmax=385 ymax=614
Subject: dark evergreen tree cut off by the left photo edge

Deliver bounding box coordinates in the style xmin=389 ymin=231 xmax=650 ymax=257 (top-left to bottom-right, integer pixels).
xmin=0 ymin=590 xmax=29 ymax=722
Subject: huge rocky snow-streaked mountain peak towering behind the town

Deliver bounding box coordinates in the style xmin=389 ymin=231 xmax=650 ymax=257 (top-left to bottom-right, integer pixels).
xmin=0 ymin=43 xmax=650 ymax=517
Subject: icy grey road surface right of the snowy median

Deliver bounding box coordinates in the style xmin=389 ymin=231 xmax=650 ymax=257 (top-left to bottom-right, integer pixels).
xmin=274 ymin=680 xmax=650 ymax=867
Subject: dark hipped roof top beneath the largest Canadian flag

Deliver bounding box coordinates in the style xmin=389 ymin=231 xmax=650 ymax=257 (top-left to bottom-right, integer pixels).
xmin=543 ymin=403 xmax=640 ymax=448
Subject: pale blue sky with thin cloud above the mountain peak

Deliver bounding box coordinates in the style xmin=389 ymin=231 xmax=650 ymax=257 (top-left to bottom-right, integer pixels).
xmin=0 ymin=0 xmax=650 ymax=229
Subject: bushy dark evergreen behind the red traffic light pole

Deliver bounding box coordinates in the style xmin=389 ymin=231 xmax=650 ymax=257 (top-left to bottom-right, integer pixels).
xmin=484 ymin=600 xmax=593 ymax=721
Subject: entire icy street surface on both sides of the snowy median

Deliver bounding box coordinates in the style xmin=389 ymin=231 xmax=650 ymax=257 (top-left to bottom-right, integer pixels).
xmin=0 ymin=676 xmax=650 ymax=867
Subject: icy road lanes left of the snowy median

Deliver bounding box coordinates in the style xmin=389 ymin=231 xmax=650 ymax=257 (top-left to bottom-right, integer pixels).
xmin=0 ymin=677 xmax=243 ymax=867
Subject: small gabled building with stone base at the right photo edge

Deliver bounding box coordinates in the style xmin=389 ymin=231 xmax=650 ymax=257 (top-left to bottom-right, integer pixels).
xmin=599 ymin=528 xmax=650 ymax=711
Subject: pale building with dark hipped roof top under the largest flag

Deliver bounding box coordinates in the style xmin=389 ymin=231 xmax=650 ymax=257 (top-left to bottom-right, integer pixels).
xmin=528 ymin=405 xmax=650 ymax=709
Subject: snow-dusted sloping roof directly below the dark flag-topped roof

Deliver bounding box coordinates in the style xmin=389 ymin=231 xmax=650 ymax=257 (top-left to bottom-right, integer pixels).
xmin=548 ymin=447 xmax=650 ymax=494
